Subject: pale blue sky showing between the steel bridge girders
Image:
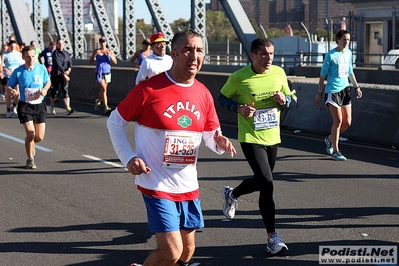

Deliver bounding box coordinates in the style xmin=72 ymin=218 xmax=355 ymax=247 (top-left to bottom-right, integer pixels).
xmin=24 ymin=0 xmax=210 ymax=24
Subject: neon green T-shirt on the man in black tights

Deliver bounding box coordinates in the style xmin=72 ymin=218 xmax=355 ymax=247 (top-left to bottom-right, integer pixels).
xmin=220 ymin=65 xmax=291 ymax=146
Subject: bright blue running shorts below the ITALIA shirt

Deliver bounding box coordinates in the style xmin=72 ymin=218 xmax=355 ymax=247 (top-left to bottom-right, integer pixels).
xmin=143 ymin=194 xmax=204 ymax=233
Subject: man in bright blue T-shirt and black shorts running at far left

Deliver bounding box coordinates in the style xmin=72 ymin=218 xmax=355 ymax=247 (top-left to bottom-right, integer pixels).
xmin=6 ymin=46 xmax=51 ymax=169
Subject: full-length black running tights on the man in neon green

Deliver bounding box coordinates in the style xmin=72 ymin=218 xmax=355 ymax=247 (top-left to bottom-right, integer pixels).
xmin=233 ymin=142 xmax=278 ymax=233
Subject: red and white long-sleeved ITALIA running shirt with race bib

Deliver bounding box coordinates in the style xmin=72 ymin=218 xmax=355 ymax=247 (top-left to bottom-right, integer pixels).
xmin=107 ymin=72 xmax=223 ymax=201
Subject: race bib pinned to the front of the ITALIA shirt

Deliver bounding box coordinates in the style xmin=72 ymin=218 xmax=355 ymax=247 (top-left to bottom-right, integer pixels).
xmin=162 ymin=134 xmax=201 ymax=168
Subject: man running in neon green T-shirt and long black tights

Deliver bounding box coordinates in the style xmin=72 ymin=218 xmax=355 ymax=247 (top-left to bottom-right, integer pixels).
xmin=218 ymin=38 xmax=295 ymax=254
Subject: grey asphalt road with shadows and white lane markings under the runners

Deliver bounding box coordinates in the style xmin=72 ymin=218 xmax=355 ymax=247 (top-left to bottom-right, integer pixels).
xmin=0 ymin=99 xmax=399 ymax=266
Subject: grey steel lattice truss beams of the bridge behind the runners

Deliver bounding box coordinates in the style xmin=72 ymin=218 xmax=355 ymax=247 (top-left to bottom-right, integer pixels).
xmin=0 ymin=0 xmax=256 ymax=60
